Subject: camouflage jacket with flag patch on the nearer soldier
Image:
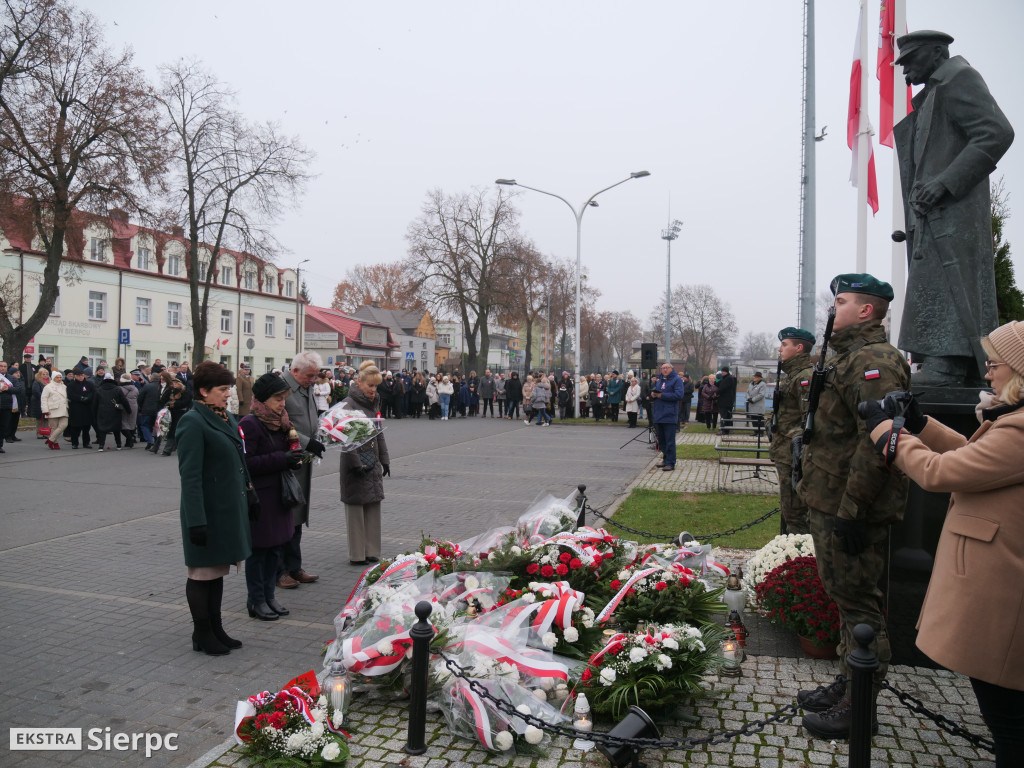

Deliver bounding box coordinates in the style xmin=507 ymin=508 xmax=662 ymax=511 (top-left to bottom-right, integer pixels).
xmin=797 ymin=321 xmax=910 ymax=524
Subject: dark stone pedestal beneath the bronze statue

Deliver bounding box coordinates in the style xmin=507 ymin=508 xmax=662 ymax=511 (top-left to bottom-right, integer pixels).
xmin=886 ymin=387 xmax=979 ymax=668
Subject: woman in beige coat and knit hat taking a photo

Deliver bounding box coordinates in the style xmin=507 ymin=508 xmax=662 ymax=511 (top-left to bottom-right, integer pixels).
xmin=866 ymin=322 xmax=1024 ymax=768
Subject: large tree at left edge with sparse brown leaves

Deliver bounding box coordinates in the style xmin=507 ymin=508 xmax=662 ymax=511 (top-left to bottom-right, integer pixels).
xmin=0 ymin=0 xmax=167 ymax=361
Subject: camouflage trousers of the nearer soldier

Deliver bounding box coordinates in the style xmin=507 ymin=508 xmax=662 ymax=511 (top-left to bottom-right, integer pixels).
xmin=810 ymin=509 xmax=892 ymax=686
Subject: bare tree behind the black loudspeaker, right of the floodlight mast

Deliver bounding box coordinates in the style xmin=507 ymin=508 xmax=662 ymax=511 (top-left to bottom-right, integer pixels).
xmin=649 ymin=285 xmax=736 ymax=373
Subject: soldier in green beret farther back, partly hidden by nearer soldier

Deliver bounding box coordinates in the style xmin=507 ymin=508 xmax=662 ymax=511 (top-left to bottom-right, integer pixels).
xmin=769 ymin=327 xmax=814 ymax=534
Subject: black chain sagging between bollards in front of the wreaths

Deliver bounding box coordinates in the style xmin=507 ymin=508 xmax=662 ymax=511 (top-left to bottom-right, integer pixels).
xmin=439 ymin=652 xmax=828 ymax=750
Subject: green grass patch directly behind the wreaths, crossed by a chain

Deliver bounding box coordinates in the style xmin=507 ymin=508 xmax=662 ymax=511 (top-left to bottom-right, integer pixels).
xmin=597 ymin=489 xmax=779 ymax=549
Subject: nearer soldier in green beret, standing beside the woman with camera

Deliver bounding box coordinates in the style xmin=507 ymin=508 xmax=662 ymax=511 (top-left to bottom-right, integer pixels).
xmin=797 ymin=274 xmax=910 ymax=739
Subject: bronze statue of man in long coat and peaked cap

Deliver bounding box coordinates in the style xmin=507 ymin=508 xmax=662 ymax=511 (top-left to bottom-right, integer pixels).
xmin=894 ymin=30 xmax=1014 ymax=387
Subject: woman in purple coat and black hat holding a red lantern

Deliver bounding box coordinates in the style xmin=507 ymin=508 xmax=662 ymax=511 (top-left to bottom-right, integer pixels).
xmin=239 ymin=374 xmax=302 ymax=622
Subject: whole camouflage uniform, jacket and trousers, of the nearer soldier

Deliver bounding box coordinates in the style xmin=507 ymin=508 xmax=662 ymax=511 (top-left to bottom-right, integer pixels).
xmin=797 ymin=321 xmax=910 ymax=682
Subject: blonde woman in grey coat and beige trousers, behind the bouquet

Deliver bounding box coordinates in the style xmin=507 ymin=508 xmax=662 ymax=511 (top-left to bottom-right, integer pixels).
xmin=340 ymin=360 xmax=391 ymax=565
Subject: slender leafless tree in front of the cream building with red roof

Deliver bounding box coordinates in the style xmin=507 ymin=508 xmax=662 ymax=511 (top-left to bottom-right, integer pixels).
xmin=160 ymin=61 xmax=313 ymax=364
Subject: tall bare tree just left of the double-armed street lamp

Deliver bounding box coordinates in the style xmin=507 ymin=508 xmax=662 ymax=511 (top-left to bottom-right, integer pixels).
xmin=406 ymin=189 xmax=519 ymax=370
